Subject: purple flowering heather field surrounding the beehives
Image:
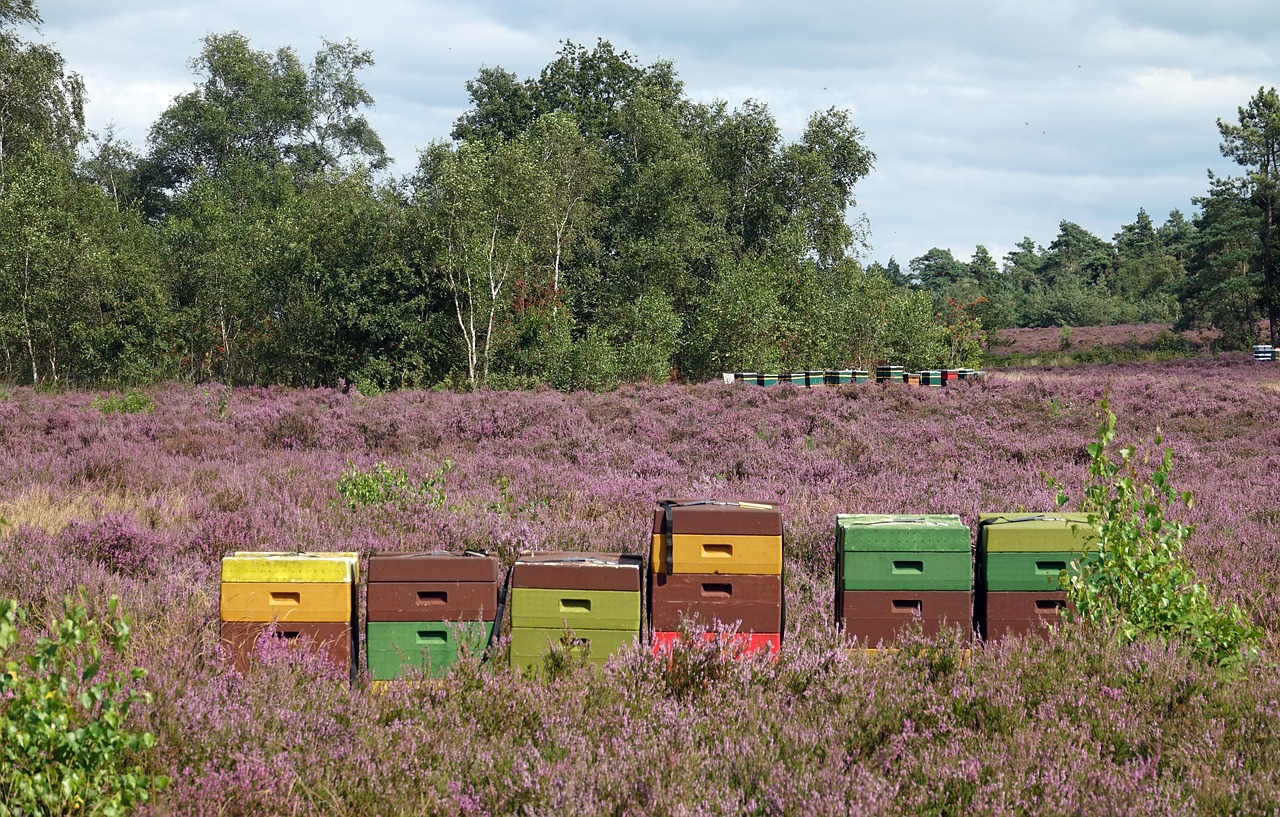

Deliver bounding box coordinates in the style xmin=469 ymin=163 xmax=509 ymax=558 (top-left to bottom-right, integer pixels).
xmin=0 ymin=355 xmax=1280 ymax=814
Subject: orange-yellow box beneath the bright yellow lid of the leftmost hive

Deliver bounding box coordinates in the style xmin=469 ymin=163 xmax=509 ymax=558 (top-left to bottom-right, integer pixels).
xmin=219 ymin=581 xmax=355 ymax=622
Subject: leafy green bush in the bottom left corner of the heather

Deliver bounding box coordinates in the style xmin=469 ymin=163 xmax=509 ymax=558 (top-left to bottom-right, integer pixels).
xmin=0 ymin=597 xmax=168 ymax=817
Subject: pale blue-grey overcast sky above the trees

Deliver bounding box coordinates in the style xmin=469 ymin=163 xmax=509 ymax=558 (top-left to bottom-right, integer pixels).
xmin=28 ymin=0 xmax=1280 ymax=266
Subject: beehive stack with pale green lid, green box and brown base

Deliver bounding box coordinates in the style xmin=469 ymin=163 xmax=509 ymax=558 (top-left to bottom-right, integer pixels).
xmin=836 ymin=514 xmax=973 ymax=647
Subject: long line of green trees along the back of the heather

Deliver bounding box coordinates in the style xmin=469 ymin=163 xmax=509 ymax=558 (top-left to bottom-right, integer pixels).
xmin=0 ymin=0 xmax=1274 ymax=389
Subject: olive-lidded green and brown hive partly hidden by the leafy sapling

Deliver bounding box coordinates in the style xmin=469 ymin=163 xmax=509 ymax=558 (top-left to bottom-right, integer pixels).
xmin=975 ymin=514 xmax=1097 ymax=640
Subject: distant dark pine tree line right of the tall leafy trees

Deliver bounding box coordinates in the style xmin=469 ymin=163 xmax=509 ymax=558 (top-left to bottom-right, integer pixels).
xmin=896 ymin=88 xmax=1280 ymax=348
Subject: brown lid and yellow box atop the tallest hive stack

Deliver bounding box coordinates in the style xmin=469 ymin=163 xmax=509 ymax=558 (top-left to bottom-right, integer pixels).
xmin=650 ymin=498 xmax=782 ymax=575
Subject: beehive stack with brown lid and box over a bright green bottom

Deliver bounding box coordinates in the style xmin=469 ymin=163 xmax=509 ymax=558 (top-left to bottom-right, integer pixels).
xmin=365 ymin=552 xmax=500 ymax=681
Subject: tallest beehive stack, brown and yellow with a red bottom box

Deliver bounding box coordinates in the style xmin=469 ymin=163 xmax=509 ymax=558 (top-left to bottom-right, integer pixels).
xmin=649 ymin=499 xmax=785 ymax=652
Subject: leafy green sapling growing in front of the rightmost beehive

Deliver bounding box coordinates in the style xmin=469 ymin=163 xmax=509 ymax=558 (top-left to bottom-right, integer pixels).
xmin=1050 ymin=398 xmax=1262 ymax=666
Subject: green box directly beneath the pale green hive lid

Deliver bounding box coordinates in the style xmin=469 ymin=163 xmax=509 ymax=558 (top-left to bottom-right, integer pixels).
xmin=836 ymin=549 xmax=973 ymax=590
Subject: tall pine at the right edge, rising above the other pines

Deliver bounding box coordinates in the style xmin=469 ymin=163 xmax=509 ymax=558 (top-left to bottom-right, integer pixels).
xmin=1217 ymin=88 xmax=1280 ymax=344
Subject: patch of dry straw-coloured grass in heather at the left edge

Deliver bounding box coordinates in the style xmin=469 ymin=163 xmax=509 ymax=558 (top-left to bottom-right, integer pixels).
xmin=0 ymin=485 xmax=187 ymax=534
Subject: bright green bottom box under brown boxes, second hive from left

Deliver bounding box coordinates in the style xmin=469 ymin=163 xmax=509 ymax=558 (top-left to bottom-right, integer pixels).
xmin=365 ymin=621 xmax=494 ymax=681
